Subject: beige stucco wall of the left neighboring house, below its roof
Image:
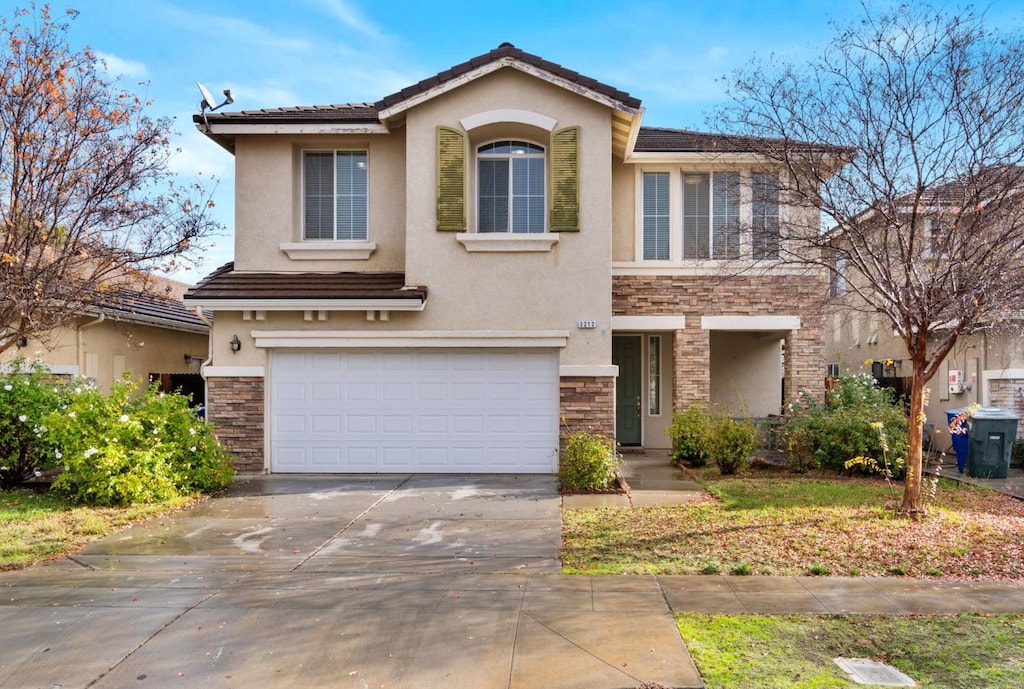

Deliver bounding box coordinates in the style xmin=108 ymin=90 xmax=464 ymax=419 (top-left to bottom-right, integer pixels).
xmin=0 ymin=318 xmax=208 ymax=391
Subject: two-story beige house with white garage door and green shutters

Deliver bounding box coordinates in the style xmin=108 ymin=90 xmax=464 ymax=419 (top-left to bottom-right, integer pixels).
xmin=185 ymin=44 xmax=827 ymax=473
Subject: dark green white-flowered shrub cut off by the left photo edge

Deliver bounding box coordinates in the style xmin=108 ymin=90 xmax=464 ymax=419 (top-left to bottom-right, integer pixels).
xmin=0 ymin=359 xmax=67 ymax=489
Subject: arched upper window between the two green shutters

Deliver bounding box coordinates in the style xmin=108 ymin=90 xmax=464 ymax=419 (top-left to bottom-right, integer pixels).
xmin=476 ymin=140 xmax=547 ymax=232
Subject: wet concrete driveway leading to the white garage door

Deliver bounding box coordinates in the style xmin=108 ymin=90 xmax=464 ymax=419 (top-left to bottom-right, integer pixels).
xmin=0 ymin=475 xmax=702 ymax=689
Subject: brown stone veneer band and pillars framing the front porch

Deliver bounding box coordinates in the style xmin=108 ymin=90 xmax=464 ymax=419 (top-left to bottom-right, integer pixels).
xmin=611 ymin=274 xmax=828 ymax=410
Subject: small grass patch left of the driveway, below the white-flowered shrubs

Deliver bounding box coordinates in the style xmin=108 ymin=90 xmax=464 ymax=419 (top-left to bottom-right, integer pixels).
xmin=0 ymin=490 xmax=195 ymax=570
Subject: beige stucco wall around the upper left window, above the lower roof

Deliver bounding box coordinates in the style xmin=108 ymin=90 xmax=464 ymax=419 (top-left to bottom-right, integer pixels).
xmin=234 ymin=128 xmax=406 ymax=272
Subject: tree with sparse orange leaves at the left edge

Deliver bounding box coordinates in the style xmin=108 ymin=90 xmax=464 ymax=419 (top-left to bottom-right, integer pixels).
xmin=0 ymin=4 xmax=218 ymax=352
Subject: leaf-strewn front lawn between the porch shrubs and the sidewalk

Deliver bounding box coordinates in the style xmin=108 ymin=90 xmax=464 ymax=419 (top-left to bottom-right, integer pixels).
xmin=562 ymin=474 xmax=1024 ymax=578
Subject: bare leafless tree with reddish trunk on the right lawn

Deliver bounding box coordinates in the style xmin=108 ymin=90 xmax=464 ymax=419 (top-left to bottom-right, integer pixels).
xmin=719 ymin=4 xmax=1024 ymax=516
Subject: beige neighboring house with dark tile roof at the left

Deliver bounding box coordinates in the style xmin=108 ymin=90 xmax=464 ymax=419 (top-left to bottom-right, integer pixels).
xmin=3 ymin=281 xmax=210 ymax=404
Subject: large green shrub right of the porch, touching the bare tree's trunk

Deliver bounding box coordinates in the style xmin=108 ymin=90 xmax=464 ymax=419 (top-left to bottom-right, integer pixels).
xmin=779 ymin=375 xmax=908 ymax=479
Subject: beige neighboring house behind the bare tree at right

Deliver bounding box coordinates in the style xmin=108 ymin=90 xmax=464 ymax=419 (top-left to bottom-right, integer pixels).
xmin=825 ymin=169 xmax=1024 ymax=451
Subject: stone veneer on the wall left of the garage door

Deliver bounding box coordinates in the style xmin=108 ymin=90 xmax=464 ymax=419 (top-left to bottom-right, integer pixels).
xmin=206 ymin=377 xmax=265 ymax=472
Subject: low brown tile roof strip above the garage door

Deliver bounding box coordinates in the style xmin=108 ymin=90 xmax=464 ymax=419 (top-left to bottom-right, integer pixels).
xmin=184 ymin=263 xmax=427 ymax=301
